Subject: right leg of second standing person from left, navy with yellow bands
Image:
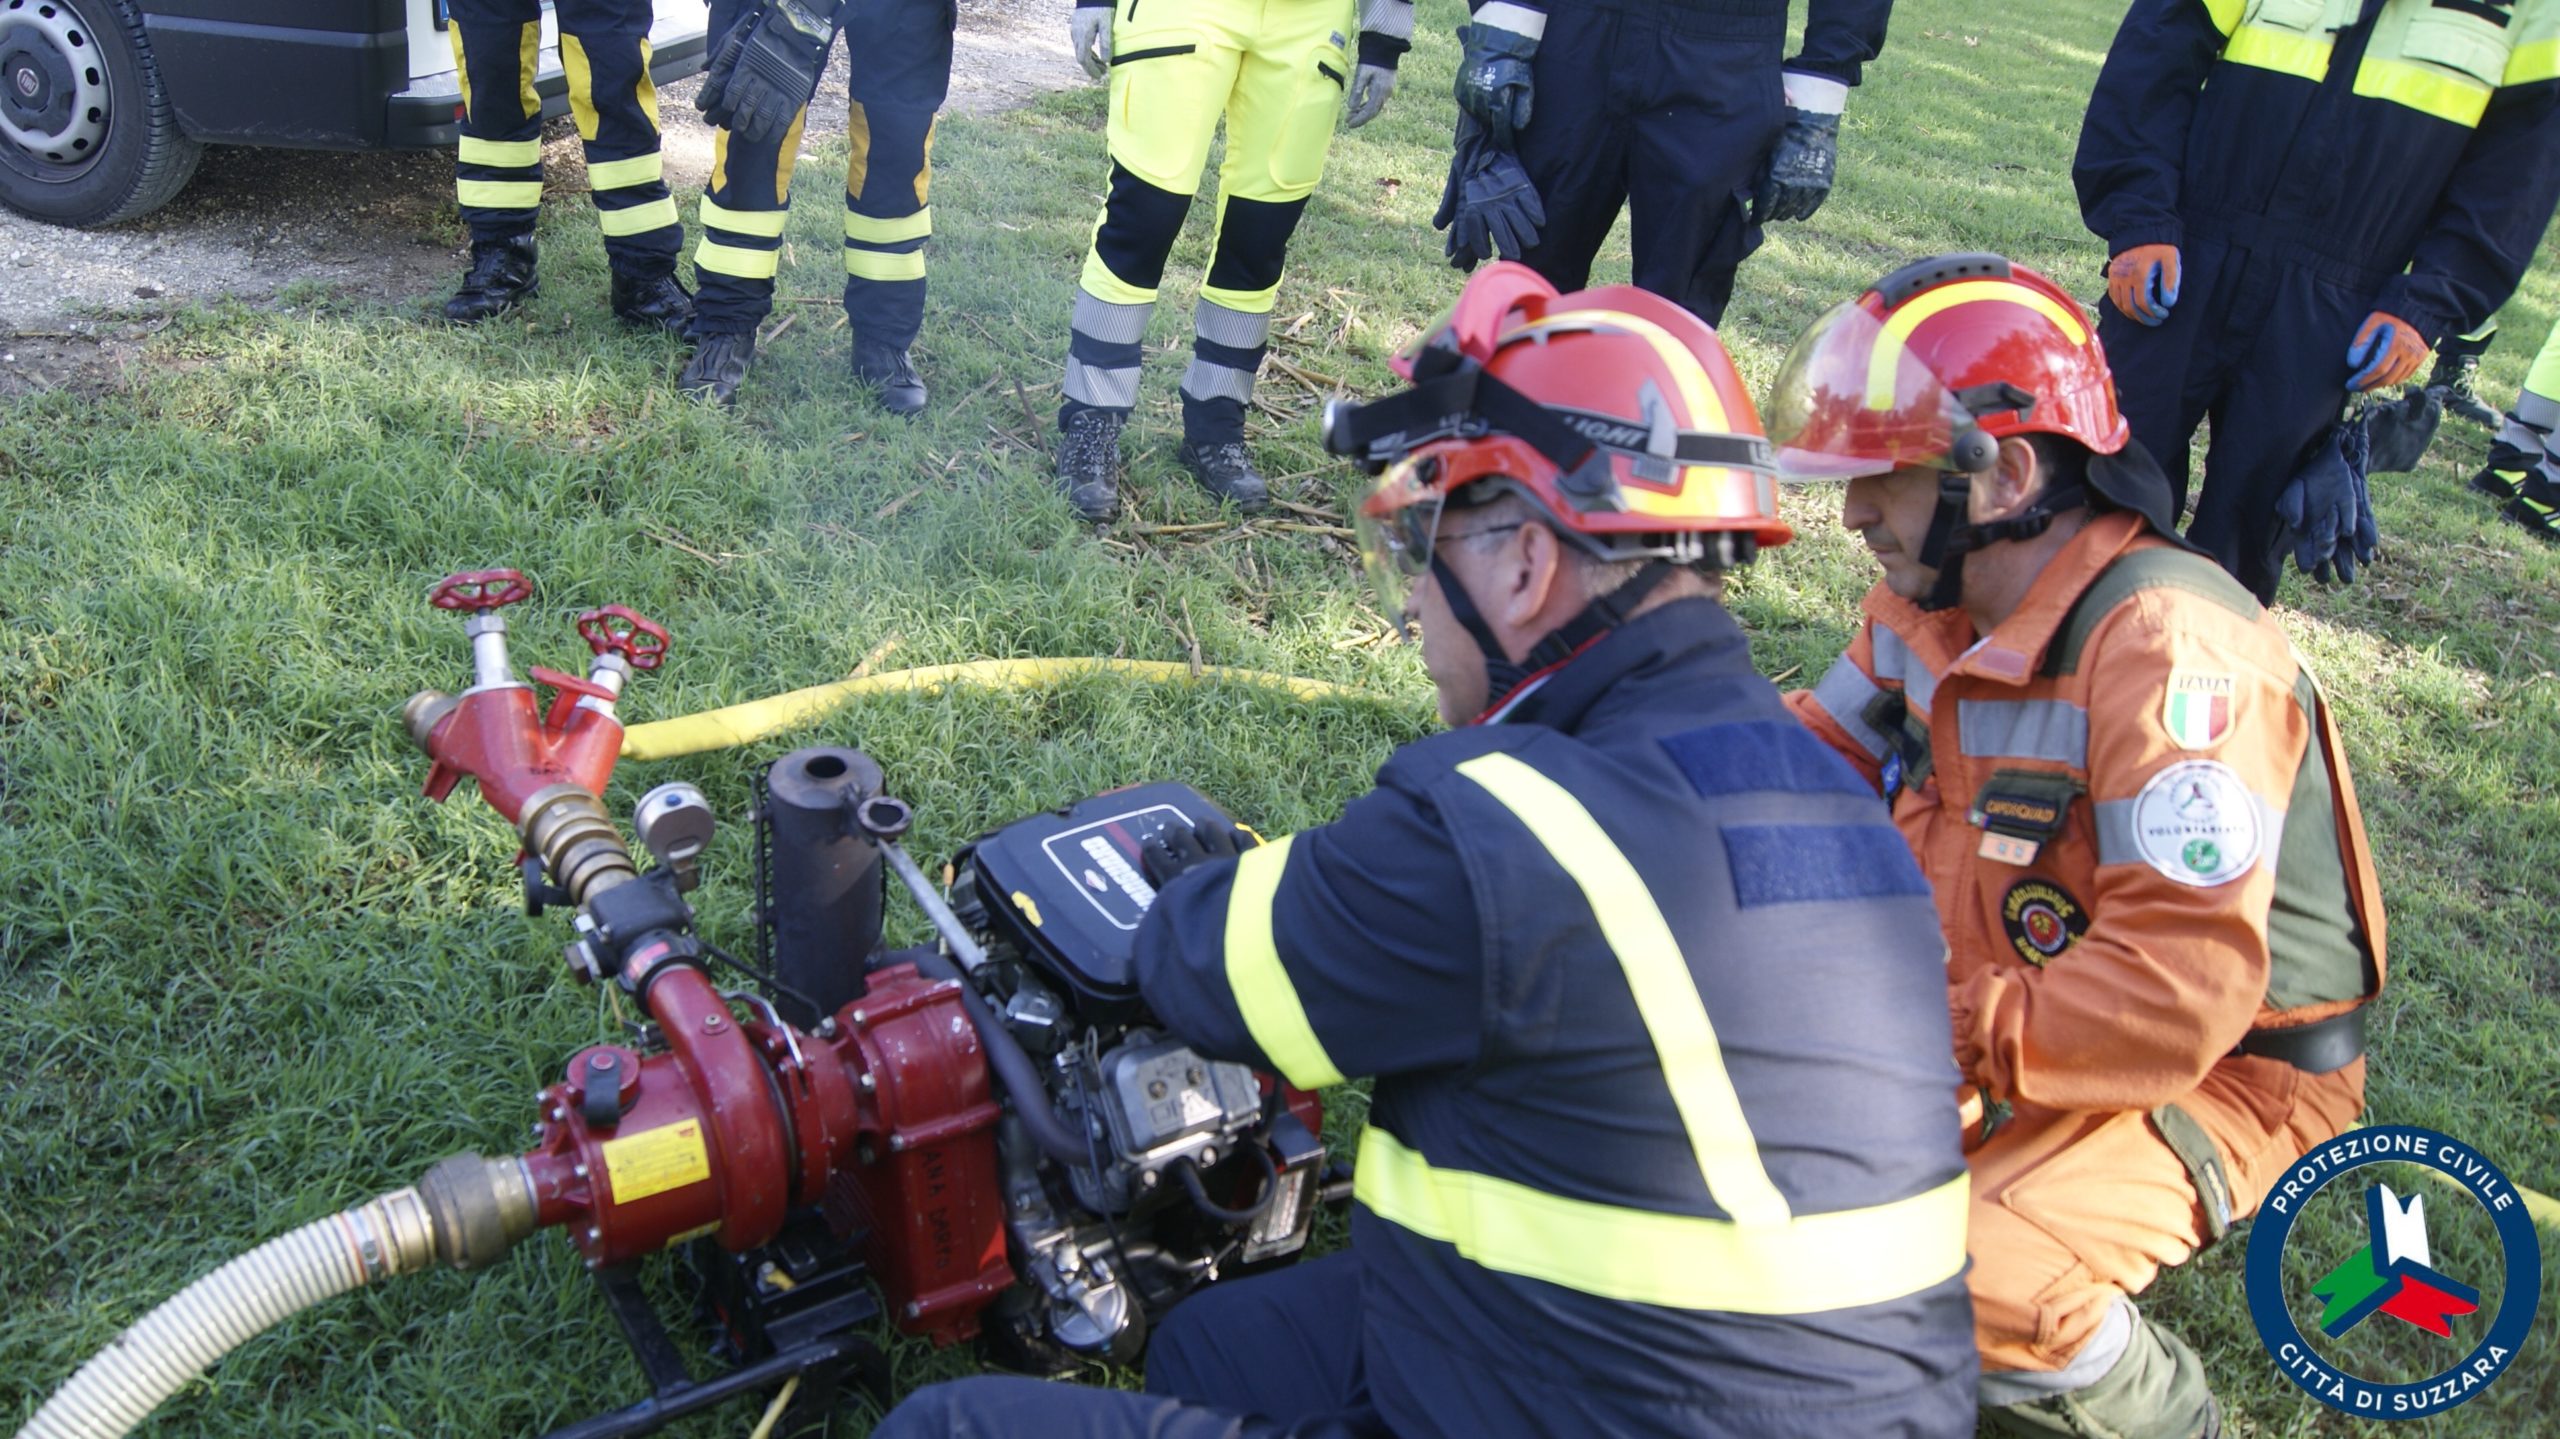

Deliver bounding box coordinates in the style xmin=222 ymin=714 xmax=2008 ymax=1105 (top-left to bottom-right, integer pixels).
xmin=845 ymin=0 xmax=960 ymax=415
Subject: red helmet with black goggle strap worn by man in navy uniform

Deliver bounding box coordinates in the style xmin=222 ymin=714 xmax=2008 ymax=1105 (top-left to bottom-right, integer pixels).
xmin=1324 ymin=261 xmax=1795 ymax=619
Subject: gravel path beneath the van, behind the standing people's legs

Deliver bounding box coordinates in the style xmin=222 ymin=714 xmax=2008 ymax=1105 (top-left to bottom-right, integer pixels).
xmin=0 ymin=0 xmax=1085 ymax=394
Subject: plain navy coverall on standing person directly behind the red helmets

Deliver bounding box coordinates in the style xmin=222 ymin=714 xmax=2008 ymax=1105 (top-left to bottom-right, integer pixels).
xmin=1469 ymin=0 xmax=1892 ymax=325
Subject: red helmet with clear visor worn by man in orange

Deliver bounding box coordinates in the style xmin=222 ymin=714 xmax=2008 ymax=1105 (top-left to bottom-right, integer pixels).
xmin=1769 ymin=253 xmax=2130 ymax=479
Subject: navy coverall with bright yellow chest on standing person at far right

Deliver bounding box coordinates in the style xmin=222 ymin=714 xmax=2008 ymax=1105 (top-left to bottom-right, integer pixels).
xmin=2071 ymin=0 xmax=2560 ymax=602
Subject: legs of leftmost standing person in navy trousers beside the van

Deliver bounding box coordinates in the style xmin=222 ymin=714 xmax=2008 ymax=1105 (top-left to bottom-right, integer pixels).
xmin=445 ymin=0 xmax=694 ymax=335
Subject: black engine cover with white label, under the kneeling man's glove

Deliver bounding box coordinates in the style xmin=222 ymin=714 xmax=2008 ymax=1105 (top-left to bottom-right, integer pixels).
xmin=955 ymin=781 xmax=1231 ymax=1022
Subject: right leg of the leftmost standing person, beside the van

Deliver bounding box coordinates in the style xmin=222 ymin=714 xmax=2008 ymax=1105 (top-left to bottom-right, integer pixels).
xmin=553 ymin=0 xmax=694 ymax=335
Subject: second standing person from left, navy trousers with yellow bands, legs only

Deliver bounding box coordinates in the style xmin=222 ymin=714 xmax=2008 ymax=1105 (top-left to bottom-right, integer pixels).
xmin=676 ymin=0 xmax=960 ymax=415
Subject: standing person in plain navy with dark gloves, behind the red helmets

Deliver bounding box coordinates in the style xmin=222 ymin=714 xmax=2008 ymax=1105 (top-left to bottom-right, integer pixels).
xmin=1441 ymin=0 xmax=1892 ymax=325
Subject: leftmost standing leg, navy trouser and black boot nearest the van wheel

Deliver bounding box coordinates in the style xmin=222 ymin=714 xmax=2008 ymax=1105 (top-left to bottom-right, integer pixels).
xmin=445 ymin=0 xmax=543 ymax=325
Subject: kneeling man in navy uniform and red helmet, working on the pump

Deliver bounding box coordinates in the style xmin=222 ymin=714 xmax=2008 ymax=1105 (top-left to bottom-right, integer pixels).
xmin=878 ymin=264 xmax=1976 ymax=1439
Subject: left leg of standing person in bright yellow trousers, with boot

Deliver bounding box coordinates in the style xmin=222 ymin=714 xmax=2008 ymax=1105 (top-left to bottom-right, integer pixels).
xmin=1057 ymin=0 xmax=1233 ymax=514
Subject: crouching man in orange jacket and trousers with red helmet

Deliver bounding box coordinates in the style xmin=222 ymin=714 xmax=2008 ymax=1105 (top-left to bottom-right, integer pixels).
xmin=1769 ymin=256 xmax=2383 ymax=1439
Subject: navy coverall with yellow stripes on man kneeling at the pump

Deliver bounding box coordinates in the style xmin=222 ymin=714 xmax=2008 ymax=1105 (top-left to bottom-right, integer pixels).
xmin=878 ymin=599 xmax=1976 ymax=1439
